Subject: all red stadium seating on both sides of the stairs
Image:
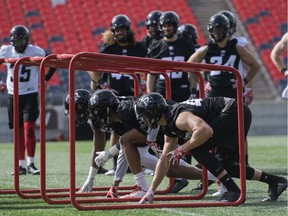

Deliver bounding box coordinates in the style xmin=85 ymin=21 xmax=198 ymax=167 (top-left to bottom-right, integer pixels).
xmin=0 ymin=0 xmax=287 ymax=103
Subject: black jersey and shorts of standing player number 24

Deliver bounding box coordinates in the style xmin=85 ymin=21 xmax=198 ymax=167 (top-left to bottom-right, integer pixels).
xmin=205 ymin=39 xmax=241 ymax=98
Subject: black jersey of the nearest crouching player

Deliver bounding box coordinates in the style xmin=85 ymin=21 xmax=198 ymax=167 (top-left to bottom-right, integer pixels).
xmin=163 ymin=97 xmax=252 ymax=150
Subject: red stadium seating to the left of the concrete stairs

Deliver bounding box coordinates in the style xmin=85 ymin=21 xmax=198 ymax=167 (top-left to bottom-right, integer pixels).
xmin=0 ymin=0 xmax=205 ymax=103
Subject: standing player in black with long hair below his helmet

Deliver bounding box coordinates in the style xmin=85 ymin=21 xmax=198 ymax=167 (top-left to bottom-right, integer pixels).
xmin=88 ymin=14 xmax=147 ymax=175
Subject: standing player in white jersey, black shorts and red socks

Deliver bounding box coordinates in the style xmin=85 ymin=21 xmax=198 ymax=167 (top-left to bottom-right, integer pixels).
xmin=0 ymin=25 xmax=56 ymax=175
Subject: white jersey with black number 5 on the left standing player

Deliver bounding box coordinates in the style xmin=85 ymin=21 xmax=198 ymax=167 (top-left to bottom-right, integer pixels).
xmin=0 ymin=44 xmax=45 ymax=95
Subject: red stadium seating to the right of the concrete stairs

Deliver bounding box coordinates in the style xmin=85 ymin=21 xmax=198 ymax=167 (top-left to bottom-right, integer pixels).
xmin=232 ymin=0 xmax=287 ymax=85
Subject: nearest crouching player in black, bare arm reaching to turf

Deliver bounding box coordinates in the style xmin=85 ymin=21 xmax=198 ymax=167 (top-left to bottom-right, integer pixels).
xmin=135 ymin=93 xmax=287 ymax=203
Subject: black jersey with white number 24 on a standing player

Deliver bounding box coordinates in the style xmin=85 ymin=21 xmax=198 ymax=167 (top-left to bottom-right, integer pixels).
xmin=205 ymin=39 xmax=241 ymax=87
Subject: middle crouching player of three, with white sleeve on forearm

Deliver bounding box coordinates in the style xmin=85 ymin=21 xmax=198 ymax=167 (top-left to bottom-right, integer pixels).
xmin=88 ymin=90 xmax=216 ymax=198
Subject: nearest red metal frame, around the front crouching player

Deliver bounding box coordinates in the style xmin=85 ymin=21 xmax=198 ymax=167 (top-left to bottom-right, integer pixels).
xmin=69 ymin=52 xmax=246 ymax=210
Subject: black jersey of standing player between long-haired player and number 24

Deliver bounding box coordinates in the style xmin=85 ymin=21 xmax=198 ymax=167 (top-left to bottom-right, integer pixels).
xmin=148 ymin=37 xmax=195 ymax=102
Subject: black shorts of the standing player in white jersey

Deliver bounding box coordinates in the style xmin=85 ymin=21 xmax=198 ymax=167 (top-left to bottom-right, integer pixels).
xmin=8 ymin=92 xmax=39 ymax=129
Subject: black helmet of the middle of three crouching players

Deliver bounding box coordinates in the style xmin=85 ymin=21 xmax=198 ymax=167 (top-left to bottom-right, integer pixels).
xmin=88 ymin=89 xmax=120 ymax=132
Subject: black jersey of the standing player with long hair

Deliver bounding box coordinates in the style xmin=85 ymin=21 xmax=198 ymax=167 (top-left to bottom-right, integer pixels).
xmin=101 ymin=42 xmax=147 ymax=96
